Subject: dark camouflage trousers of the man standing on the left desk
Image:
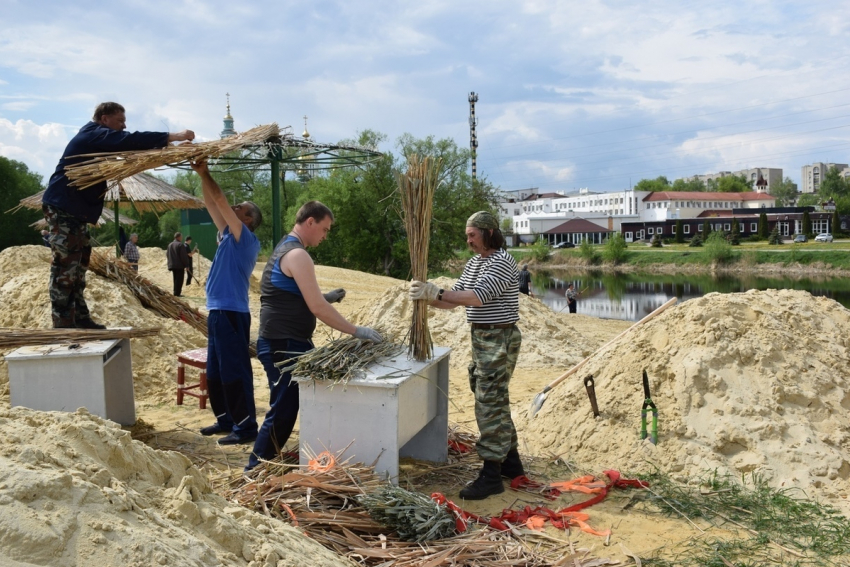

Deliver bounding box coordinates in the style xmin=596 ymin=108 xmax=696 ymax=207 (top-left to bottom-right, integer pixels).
xmin=42 ymin=205 xmax=91 ymax=328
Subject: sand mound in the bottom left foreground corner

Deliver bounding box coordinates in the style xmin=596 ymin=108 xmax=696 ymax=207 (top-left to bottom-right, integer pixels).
xmin=0 ymin=408 xmax=350 ymax=567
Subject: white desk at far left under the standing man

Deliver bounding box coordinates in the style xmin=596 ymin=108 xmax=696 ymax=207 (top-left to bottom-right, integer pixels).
xmin=6 ymin=339 xmax=136 ymax=425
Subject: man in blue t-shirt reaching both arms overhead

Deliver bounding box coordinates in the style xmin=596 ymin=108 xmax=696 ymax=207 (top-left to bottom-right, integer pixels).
xmin=192 ymin=161 xmax=263 ymax=445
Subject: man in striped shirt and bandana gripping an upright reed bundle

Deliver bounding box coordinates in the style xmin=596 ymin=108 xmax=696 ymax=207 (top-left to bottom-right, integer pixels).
xmin=410 ymin=211 xmax=525 ymax=500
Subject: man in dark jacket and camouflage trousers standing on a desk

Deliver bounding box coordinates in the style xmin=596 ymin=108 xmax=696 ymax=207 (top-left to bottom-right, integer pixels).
xmin=42 ymin=102 xmax=195 ymax=329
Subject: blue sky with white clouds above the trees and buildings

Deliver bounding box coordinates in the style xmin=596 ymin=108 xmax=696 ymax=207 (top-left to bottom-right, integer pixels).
xmin=0 ymin=0 xmax=850 ymax=193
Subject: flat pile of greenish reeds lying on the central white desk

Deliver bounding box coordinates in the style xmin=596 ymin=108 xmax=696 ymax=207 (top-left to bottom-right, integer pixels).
xmin=275 ymin=329 xmax=404 ymax=384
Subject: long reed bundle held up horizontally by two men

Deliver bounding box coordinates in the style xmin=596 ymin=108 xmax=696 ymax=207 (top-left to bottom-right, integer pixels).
xmin=65 ymin=123 xmax=280 ymax=189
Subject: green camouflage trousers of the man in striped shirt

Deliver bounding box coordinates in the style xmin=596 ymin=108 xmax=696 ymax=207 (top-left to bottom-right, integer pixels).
xmin=469 ymin=326 xmax=522 ymax=462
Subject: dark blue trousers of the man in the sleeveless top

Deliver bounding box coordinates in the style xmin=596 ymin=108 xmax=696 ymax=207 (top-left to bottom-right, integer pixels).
xmin=246 ymin=337 xmax=313 ymax=469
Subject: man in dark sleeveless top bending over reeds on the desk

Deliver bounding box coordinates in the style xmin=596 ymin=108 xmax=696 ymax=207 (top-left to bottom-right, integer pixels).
xmin=245 ymin=201 xmax=383 ymax=471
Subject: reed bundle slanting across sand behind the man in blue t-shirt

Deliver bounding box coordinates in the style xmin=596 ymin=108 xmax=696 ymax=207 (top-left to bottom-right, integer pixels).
xmin=89 ymin=251 xmax=207 ymax=336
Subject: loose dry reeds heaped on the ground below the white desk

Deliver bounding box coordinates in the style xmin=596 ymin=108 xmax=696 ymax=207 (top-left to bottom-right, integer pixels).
xmin=223 ymin=450 xmax=592 ymax=567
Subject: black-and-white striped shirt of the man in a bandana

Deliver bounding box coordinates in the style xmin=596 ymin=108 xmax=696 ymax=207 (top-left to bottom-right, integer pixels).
xmin=452 ymin=250 xmax=519 ymax=325
